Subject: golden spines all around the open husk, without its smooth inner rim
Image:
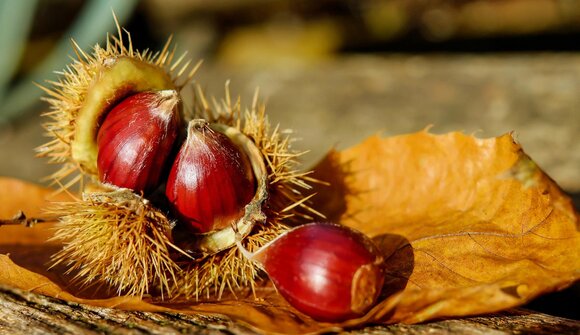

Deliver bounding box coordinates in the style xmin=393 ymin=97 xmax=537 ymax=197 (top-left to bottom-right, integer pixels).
xmin=37 ymin=19 xmax=322 ymax=299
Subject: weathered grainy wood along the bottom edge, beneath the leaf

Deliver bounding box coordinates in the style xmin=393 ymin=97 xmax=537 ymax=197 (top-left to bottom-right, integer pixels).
xmin=0 ymin=286 xmax=580 ymax=335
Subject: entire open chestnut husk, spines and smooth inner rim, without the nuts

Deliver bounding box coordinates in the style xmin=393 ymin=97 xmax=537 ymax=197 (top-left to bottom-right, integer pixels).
xmin=37 ymin=27 xmax=319 ymax=300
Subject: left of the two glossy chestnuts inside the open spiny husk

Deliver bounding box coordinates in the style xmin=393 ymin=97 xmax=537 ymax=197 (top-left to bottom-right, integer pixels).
xmin=97 ymin=90 xmax=180 ymax=193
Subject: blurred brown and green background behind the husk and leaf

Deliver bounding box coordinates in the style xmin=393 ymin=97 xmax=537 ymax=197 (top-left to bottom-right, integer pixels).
xmin=0 ymin=0 xmax=580 ymax=319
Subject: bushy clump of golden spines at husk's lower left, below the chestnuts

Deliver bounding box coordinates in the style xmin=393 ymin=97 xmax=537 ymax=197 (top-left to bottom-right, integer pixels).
xmin=50 ymin=189 xmax=181 ymax=297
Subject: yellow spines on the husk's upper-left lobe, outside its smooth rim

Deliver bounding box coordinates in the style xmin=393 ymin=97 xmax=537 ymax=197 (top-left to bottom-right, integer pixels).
xmin=36 ymin=23 xmax=200 ymax=190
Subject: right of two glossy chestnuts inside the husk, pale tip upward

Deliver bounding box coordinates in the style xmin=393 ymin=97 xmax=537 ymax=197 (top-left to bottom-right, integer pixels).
xmin=165 ymin=120 xmax=256 ymax=233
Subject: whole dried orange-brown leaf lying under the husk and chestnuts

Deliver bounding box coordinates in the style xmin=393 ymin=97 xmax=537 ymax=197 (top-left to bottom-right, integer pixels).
xmin=0 ymin=131 xmax=580 ymax=333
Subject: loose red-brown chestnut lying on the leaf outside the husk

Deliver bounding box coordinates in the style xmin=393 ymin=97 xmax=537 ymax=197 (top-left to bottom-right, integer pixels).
xmin=246 ymin=223 xmax=384 ymax=322
